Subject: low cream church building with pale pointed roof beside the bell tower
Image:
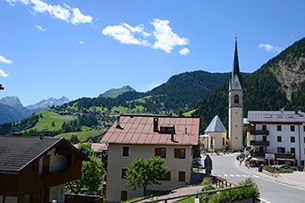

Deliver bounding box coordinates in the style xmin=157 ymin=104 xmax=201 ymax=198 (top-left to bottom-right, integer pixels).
xmin=200 ymin=115 xmax=228 ymax=151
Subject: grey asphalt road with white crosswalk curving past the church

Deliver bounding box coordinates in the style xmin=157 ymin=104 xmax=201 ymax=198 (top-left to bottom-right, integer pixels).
xmin=202 ymin=154 xmax=305 ymax=203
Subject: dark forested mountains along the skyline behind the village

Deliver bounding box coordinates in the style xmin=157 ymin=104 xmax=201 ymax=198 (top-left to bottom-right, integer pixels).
xmin=0 ymin=38 xmax=305 ymax=126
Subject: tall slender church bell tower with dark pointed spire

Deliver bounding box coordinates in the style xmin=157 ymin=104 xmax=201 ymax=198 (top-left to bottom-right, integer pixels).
xmin=229 ymin=38 xmax=243 ymax=150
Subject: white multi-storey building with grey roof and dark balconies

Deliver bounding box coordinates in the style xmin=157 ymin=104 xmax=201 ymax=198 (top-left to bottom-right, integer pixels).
xmin=247 ymin=109 xmax=305 ymax=167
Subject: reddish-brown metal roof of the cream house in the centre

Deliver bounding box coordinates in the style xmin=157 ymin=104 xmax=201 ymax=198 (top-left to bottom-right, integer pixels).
xmin=101 ymin=115 xmax=200 ymax=145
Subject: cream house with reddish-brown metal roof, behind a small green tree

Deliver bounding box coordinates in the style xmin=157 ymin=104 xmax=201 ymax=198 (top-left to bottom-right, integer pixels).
xmin=101 ymin=115 xmax=200 ymax=202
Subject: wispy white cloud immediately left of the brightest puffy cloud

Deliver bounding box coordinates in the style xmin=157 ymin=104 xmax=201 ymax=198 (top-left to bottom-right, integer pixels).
xmin=102 ymin=23 xmax=149 ymax=46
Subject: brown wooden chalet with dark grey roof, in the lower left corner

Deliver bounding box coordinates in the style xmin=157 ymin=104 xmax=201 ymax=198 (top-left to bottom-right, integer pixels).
xmin=0 ymin=136 xmax=88 ymax=203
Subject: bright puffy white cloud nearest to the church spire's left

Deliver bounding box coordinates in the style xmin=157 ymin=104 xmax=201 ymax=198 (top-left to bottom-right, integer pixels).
xmin=151 ymin=19 xmax=189 ymax=53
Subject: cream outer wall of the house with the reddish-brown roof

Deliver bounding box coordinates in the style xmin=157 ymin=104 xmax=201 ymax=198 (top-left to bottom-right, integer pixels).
xmin=106 ymin=144 xmax=193 ymax=202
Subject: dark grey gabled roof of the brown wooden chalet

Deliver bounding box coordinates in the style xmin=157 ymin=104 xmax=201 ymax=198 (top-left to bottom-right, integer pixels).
xmin=0 ymin=136 xmax=85 ymax=173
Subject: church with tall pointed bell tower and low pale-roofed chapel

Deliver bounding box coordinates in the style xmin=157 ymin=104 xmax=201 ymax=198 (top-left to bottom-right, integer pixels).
xmin=200 ymin=38 xmax=243 ymax=151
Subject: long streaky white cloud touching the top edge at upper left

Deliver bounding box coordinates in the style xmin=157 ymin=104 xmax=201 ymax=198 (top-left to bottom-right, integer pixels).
xmin=6 ymin=0 xmax=93 ymax=24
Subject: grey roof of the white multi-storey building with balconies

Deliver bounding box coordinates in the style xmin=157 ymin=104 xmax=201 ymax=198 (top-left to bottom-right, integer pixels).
xmin=248 ymin=110 xmax=305 ymax=123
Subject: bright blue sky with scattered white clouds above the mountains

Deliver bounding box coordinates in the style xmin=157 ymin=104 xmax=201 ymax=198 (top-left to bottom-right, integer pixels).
xmin=0 ymin=0 xmax=305 ymax=106
